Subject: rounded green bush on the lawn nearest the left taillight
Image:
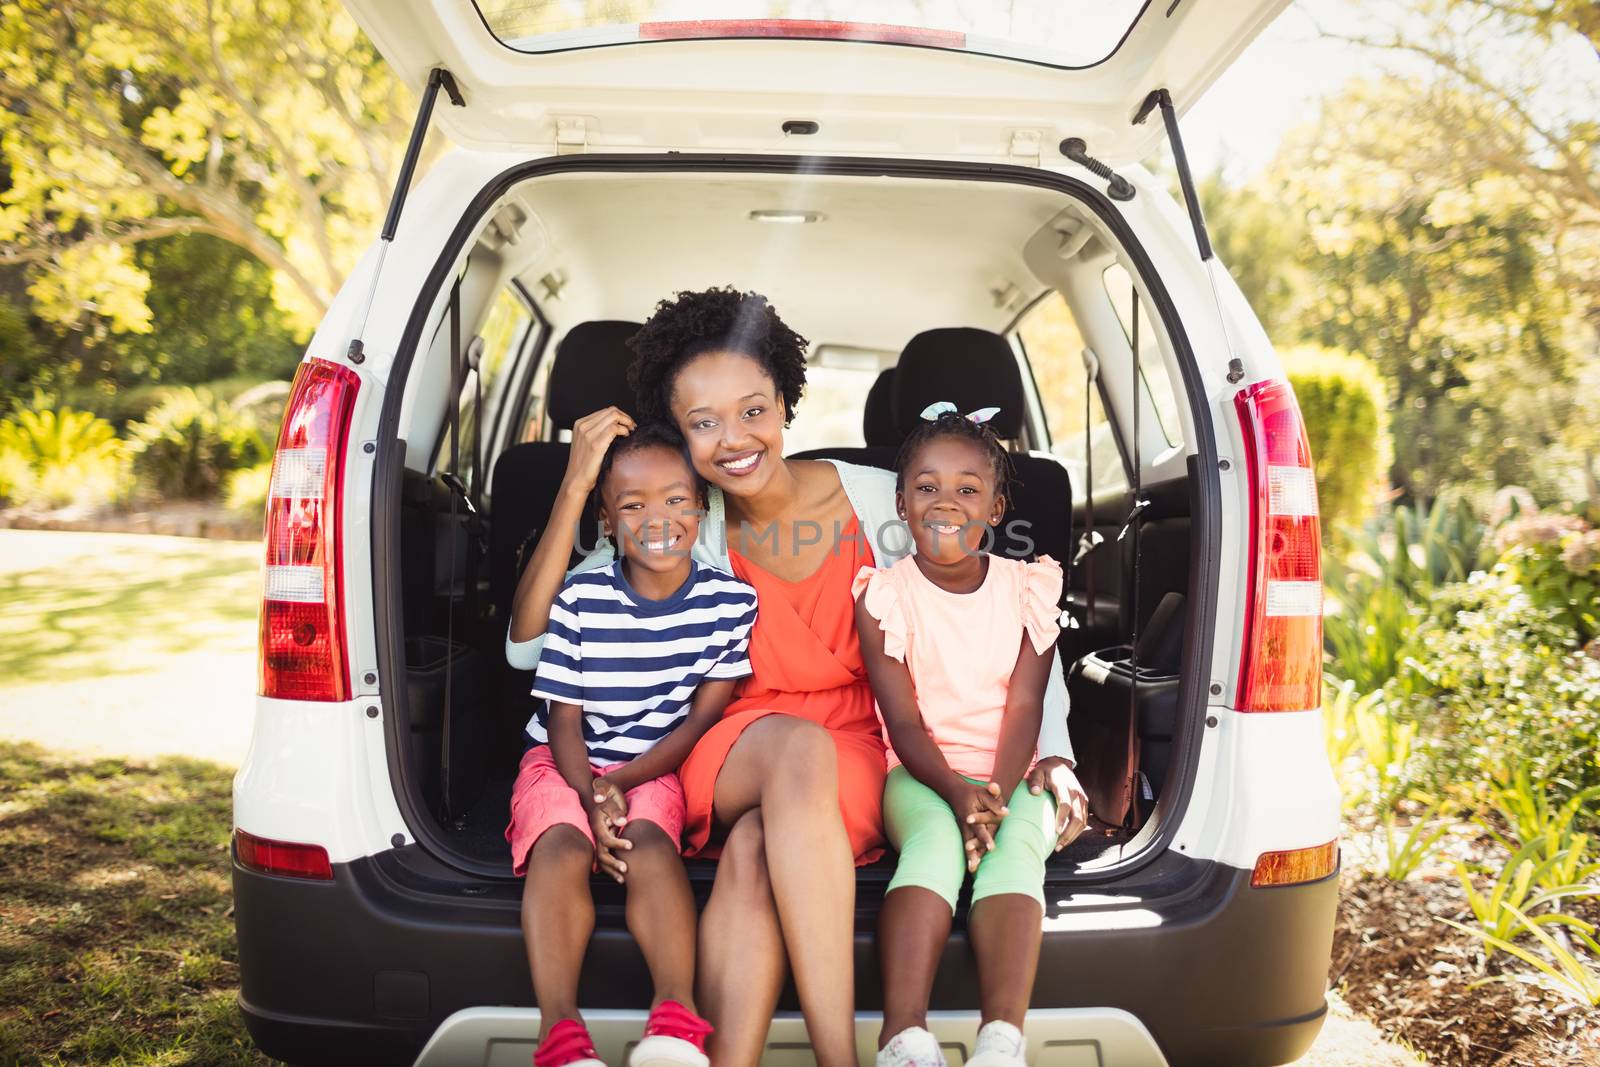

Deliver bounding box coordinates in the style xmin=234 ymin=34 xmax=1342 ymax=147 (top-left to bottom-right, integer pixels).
xmin=128 ymin=387 xmax=270 ymax=498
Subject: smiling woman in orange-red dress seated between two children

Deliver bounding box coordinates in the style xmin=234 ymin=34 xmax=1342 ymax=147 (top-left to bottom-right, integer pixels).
xmin=507 ymin=290 xmax=1085 ymax=1067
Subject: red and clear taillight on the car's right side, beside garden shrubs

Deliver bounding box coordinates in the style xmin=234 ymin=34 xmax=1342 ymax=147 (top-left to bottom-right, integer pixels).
xmin=1234 ymin=381 xmax=1322 ymax=712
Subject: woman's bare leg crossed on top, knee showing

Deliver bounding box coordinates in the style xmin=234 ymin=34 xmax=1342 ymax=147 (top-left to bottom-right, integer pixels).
xmin=706 ymin=715 xmax=856 ymax=1067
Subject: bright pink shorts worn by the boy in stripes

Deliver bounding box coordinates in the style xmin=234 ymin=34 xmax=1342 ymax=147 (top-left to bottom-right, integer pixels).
xmin=506 ymin=745 xmax=683 ymax=877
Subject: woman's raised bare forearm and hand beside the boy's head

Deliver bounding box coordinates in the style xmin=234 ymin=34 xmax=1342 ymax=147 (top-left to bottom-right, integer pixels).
xmin=510 ymin=408 xmax=634 ymax=641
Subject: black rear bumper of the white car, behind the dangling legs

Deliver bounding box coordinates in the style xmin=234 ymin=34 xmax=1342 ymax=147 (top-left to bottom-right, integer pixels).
xmin=234 ymin=849 xmax=1338 ymax=1067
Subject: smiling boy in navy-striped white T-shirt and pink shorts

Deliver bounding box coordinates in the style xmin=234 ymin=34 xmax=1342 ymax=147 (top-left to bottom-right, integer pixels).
xmin=506 ymin=424 xmax=755 ymax=1067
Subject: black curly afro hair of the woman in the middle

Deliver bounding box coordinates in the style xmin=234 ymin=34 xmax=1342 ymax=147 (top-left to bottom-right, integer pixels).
xmin=627 ymin=286 xmax=806 ymax=426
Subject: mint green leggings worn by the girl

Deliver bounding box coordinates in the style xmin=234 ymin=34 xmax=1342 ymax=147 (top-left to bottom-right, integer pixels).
xmin=883 ymin=766 xmax=1056 ymax=912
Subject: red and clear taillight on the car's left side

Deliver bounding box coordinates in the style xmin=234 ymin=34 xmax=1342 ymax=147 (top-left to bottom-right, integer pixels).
xmin=261 ymin=360 xmax=360 ymax=701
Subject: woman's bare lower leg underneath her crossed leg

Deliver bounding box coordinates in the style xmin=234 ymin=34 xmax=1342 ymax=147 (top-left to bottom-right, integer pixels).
xmin=696 ymin=809 xmax=786 ymax=1067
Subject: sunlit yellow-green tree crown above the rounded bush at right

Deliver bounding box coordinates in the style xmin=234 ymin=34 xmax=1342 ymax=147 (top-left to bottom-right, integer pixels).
xmin=1228 ymin=60 xmax=1600 ymax=499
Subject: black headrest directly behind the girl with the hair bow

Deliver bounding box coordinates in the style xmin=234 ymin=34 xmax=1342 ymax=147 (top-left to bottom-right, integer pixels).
xmin=891 ymin=326 xmax=1024 ymax=440
